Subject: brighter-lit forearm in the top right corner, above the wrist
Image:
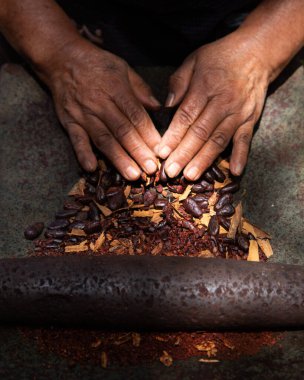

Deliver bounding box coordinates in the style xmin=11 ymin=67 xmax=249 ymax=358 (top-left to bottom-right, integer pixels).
xmin=235 ymin=0 xmax=304 ymax=82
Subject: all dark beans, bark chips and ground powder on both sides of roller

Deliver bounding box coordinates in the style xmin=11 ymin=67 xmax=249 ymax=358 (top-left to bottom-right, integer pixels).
xmin=21 ymin=150 xmax=280 ymax=368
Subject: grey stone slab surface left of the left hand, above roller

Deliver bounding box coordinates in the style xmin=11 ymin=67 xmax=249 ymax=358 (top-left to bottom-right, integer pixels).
xmin=0 ymin=64 xmax=78 ymax=255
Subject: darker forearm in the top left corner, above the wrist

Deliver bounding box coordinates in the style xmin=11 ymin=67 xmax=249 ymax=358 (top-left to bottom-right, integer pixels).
xmin=0 ymin=0 xmax=81 ymax=77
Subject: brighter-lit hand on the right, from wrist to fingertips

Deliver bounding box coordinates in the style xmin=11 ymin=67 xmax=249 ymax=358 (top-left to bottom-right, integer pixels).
xmin=158 ymin=32 xmax=269 ymax=180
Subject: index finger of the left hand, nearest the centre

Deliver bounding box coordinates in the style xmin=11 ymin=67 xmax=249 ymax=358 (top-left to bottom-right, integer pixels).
xmin=107 ymin=91 xmax=161 ymax=160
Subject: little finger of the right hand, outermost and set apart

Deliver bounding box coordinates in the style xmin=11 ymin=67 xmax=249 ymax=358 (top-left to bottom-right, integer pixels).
xmin=230 ymin=121 xmax=254 ymax=176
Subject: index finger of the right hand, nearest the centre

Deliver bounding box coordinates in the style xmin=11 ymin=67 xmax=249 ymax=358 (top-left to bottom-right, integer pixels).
xmin=158 ymin=89 xmax=207 ymax=159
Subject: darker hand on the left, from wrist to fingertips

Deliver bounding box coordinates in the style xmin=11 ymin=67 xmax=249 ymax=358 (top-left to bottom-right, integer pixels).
xmin=47 ymin=41 xmax=160 ymax=180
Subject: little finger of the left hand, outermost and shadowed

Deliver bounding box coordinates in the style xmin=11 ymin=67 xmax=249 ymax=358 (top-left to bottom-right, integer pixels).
xmin=65 ymin=123 xmax=97 ymax=172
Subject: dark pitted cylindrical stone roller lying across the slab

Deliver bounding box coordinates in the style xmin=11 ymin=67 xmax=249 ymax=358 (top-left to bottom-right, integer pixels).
xmin=0 ymin=256 xmax=304 ymax=331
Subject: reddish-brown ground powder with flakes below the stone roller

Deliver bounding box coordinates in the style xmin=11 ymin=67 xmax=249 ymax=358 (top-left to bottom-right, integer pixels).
xmin=21 ymin=328 xmax=281 ymax=367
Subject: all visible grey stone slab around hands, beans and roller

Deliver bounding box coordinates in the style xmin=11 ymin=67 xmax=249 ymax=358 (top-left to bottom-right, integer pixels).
xmin=0 ymin=61 xmax=304 ymax=380
